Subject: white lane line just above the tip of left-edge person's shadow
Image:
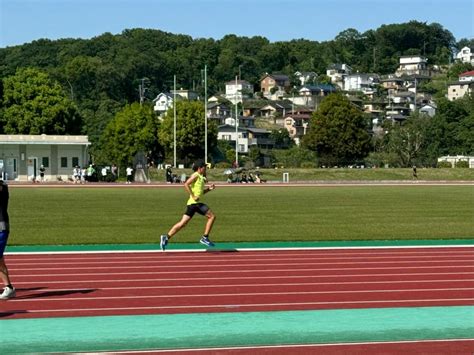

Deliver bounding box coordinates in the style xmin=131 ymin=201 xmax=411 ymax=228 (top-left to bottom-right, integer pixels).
xmin=11 ymin=272 xmax=474 ymax=285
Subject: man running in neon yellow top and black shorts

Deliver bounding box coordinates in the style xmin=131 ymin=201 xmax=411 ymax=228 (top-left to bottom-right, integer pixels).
xmin=160 ymin=161 xmax=216 ymax=251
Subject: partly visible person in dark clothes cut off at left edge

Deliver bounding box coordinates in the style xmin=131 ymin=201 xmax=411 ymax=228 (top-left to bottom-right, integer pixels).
xmin=0 ymin=180 xmax=16 ymax=300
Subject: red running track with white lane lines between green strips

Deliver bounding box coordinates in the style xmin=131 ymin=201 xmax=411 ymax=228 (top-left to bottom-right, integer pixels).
xmin=0 ymin=247 xmax=474 ymax=319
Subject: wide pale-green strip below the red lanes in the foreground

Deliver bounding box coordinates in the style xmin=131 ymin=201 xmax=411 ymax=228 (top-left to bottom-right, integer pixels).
xmin=0 ymin=306 xmax=474 ymax=354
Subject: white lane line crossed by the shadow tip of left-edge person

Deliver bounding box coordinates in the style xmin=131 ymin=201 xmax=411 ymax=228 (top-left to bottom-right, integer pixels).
xmin=15 ymin=279 xmax=474 ymax=293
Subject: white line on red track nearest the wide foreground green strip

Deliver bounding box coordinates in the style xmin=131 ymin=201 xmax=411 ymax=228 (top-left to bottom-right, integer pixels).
xmin=11 ymin=298 xmax=474 ymax=313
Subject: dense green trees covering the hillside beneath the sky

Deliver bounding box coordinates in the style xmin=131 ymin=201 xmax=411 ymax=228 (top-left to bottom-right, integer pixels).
xmin=0 ymin=21 xmax=474 ymax=167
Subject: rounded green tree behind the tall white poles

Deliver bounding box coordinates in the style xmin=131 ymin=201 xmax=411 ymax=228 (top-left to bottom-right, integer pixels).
xmin=159 ymin=101 xmax=217 ymax=162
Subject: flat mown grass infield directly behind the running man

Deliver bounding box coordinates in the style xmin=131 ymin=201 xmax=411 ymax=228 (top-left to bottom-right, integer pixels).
xmin=9 ymin=184 xmax=474 ymax=245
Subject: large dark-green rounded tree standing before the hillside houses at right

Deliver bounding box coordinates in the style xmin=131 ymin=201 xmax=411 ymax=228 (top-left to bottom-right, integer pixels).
xmin=302 ymin=94 xmax=370 ymax=166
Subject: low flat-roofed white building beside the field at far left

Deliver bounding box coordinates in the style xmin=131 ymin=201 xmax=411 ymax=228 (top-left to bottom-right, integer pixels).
xmin=0 ymin=134 xmax=90 ymax=181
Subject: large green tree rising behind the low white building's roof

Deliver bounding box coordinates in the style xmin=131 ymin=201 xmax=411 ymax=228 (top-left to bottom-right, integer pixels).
xmin=0 ymin=68 xmax=81 ymax=134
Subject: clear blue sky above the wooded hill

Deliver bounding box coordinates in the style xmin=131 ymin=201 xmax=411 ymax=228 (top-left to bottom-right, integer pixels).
xmin=0 ymin=0 xmax=474 ymax=47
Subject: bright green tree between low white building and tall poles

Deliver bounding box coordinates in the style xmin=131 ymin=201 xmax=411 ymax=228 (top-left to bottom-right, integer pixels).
xmin=101 ymin=103 xmax=161 ymax=166
